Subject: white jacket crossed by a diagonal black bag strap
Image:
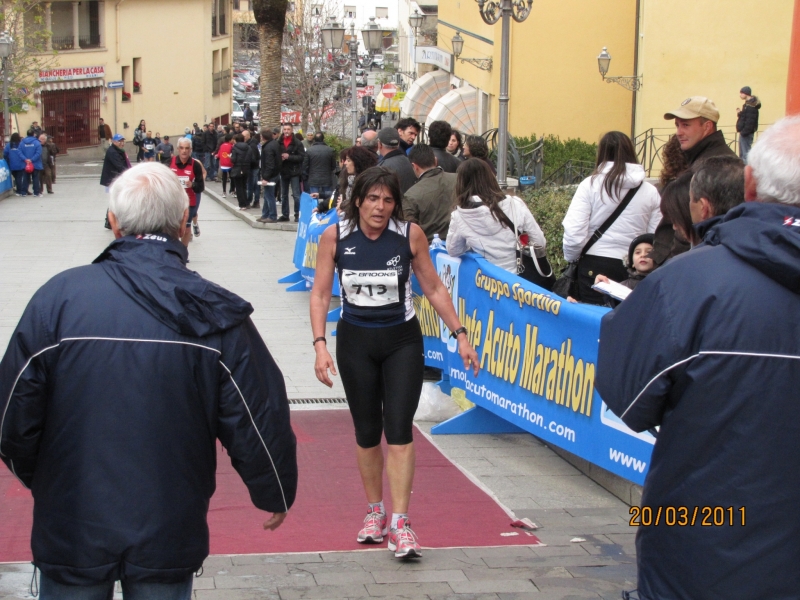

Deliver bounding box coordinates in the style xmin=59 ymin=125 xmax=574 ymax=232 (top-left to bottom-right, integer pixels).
xmin=563 ymin=163 xmax=661 ymax=262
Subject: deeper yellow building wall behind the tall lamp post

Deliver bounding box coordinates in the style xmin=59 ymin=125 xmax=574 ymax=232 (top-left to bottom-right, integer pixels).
xmin=438 ymin=0 xmax=636 ymax=141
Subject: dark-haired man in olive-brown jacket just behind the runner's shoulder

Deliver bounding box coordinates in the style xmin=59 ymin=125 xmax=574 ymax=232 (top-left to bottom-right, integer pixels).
xmin=403 ymin=144 xmax=456 ymax=243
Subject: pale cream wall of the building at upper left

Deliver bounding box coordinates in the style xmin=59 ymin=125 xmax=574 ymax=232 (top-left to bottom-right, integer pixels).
xmin=19 ymin=0 xmax=233 ymax=139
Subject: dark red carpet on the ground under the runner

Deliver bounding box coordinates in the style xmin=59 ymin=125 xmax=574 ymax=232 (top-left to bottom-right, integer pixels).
xmin=0 ymin=410 xmax=540 ymax=562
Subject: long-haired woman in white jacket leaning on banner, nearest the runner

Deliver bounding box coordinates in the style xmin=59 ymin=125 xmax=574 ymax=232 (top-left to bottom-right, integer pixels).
xmin=447 ymin=158 xmax=547 ymax=274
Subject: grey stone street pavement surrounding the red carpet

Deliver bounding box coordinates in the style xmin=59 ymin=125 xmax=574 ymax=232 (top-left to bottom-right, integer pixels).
xmin=0 ymin=178 xmax=636 ymax=600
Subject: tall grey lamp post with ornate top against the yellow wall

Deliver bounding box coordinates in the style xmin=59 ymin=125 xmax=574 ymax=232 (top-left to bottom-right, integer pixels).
xmin=476 ymin=0 xmax=533 ymax=188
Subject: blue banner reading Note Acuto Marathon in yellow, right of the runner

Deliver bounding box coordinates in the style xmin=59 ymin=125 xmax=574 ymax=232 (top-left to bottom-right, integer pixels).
xmin=414 ymin=250 xmax=655 ymax=484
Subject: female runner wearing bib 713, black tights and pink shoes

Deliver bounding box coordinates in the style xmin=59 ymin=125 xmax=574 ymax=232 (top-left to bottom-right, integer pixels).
xmin=311 ymin=166 xmax=478 ymax=558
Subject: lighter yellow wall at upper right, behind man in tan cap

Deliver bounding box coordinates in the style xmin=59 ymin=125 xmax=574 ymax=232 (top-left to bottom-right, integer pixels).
xmin=636 ymin=0 xmax=794 ymax=141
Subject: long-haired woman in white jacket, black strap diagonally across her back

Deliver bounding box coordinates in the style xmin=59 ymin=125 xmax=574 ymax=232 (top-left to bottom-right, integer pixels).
xmin=563 ymin=131 xmax=661 ymax=305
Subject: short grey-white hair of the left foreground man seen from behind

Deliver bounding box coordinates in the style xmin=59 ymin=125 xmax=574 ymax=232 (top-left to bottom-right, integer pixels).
xmin=109 ymin=162 xmax=189 ymax=237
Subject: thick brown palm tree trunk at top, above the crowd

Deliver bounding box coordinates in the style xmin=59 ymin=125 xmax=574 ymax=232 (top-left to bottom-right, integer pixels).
xmin=250 ymin=0 xmax=289 ymax=125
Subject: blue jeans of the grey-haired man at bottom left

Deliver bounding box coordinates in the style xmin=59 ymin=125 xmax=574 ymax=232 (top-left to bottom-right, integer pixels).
xmin=39 ymin=573 xmax=194 ymax=600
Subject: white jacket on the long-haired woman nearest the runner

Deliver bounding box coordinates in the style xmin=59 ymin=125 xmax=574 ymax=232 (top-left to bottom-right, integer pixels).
xmin=447 ymin=196 xmax=547 ymax=273
